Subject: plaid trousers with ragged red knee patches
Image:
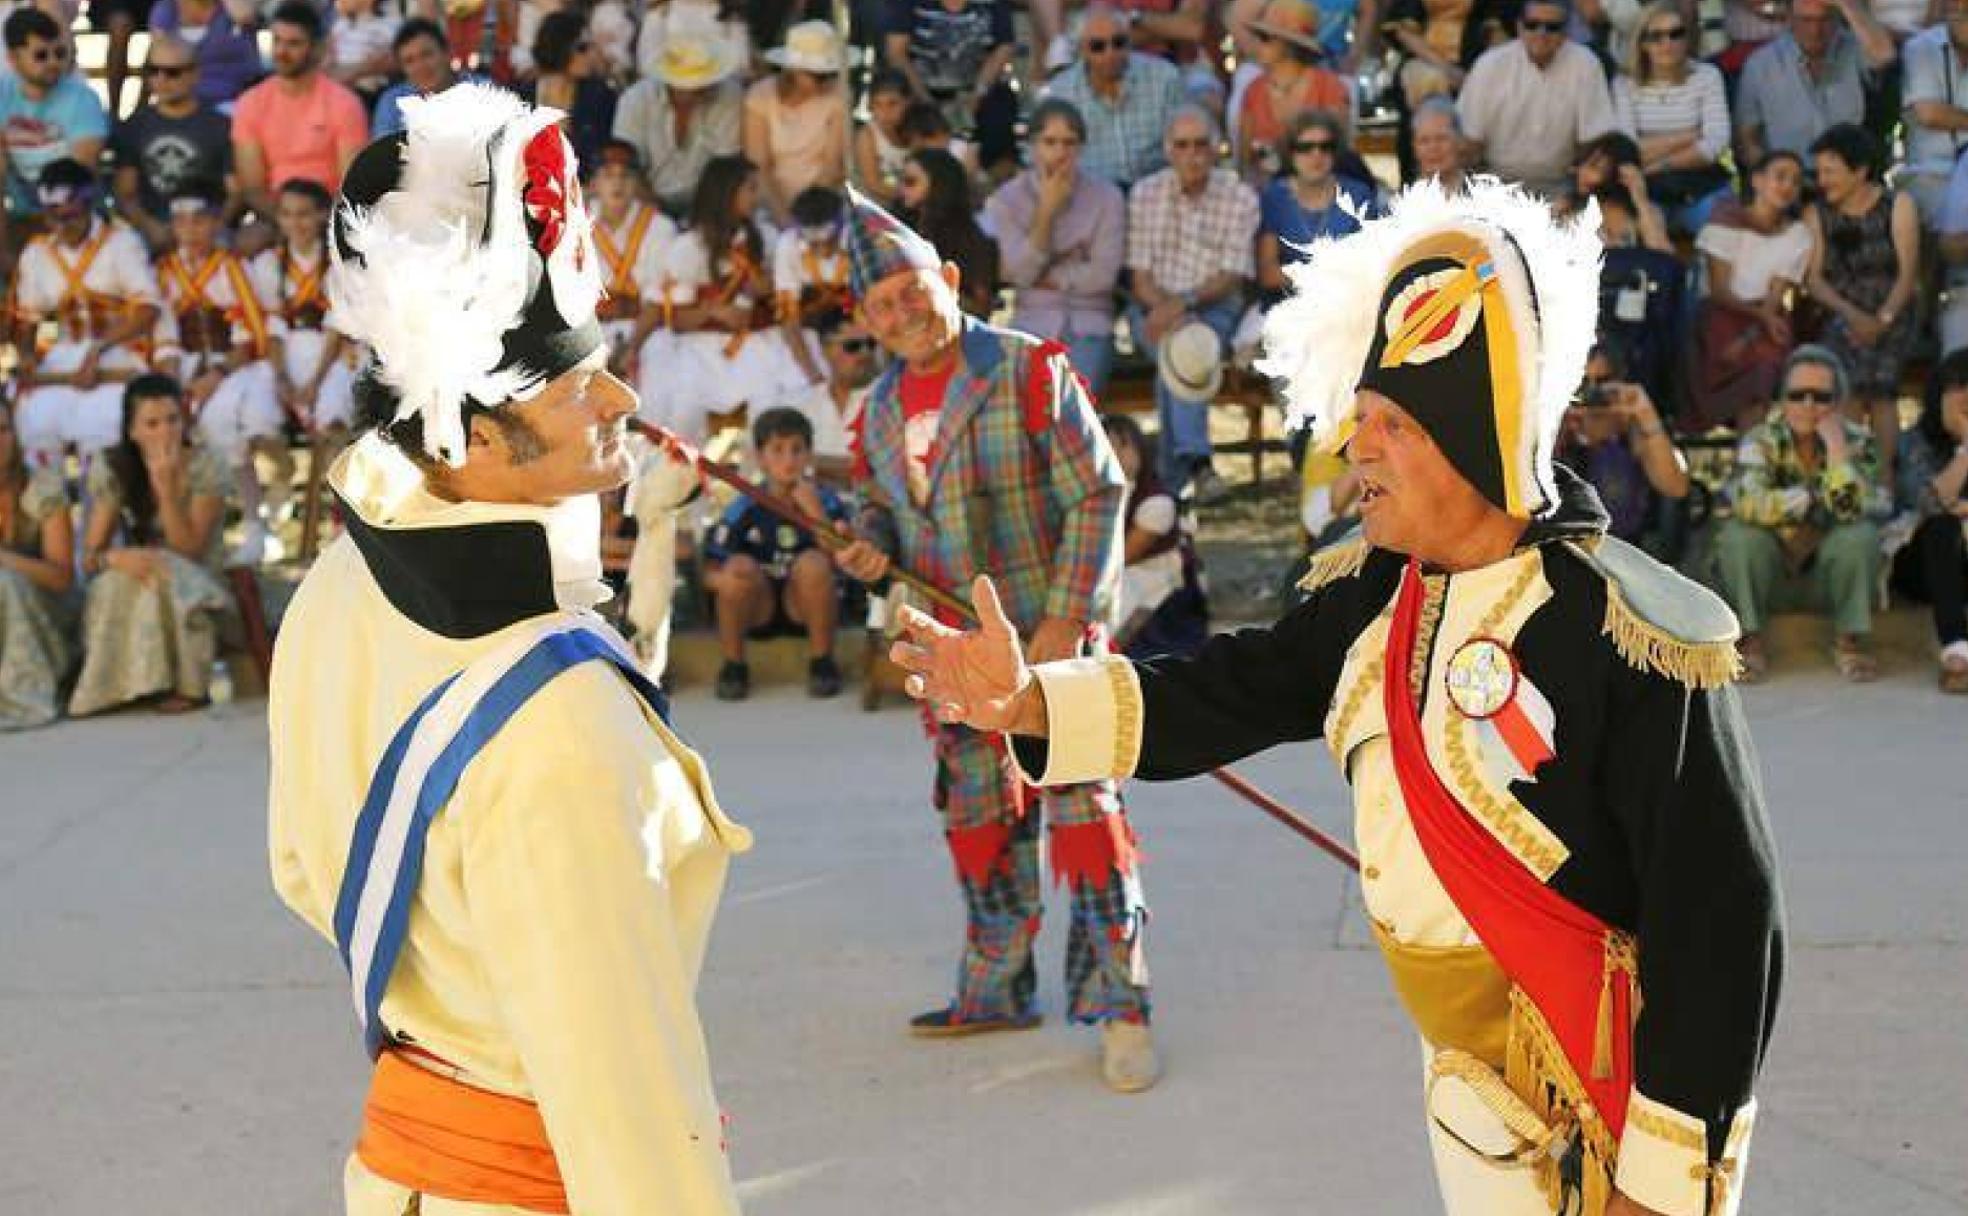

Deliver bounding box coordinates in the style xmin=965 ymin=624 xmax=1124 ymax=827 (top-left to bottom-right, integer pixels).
xmin=935 ymin=726 xmax=1149 ymax=1023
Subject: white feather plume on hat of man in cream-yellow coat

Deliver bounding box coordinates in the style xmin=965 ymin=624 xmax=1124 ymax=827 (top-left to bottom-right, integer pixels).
xmin=329 ymin=83 xmax=574 ymax=464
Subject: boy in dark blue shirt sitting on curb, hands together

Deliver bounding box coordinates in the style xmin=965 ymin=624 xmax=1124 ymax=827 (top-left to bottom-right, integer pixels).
xmin=705 ymin=409 xmax=846 ymax=700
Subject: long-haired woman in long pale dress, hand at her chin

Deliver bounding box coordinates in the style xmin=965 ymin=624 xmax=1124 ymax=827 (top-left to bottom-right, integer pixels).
xmin=69 ymin=376 xmax=232 ymax=718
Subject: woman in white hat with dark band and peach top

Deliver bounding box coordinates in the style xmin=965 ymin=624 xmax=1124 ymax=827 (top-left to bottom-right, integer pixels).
xmin=744 ymin=22 xmax=848 ymax=228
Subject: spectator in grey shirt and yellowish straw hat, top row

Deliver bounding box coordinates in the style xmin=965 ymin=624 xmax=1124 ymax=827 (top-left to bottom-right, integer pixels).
xmin=614 ymin=30 xmax=744 ymax=216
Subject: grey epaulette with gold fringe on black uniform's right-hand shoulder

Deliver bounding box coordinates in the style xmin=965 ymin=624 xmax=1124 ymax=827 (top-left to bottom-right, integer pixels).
xmin=1567 ymin=537 xmax=1742 ymax=691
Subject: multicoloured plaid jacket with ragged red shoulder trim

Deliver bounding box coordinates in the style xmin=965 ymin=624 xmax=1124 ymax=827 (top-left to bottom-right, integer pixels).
xmin=856 ymin=317 xmax=1128 ymax=634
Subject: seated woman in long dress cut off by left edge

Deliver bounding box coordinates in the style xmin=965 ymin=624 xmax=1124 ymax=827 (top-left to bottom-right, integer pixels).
xmin=0 ymin=401 xmax=75 ymax=730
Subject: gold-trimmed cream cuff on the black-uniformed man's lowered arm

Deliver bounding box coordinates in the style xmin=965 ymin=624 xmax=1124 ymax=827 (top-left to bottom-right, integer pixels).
xmin=1614 ymin=1088 xmax=1755 ymax=1216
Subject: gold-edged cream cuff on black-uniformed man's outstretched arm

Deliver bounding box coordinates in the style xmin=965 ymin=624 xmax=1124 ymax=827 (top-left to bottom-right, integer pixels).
xmin=1012 ymin=655 xmax=1141 ymax=785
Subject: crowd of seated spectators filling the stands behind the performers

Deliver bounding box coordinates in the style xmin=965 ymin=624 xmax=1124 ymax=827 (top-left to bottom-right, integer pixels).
xmin=0 ymin=0 xmax=1968 ymax=724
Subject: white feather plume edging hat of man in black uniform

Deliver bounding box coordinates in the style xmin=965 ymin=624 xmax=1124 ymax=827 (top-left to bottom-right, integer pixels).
xmin=1258 ymin=177 xmax=1602 ymax=500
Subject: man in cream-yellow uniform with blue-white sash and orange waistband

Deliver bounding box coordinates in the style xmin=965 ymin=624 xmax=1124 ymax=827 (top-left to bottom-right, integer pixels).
xmin=268 ymin=85 xmax=750 ymax=1216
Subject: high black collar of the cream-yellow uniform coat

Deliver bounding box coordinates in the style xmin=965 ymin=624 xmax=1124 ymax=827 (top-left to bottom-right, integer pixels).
xmin=335 ymin=494 xmax=559 ymax=639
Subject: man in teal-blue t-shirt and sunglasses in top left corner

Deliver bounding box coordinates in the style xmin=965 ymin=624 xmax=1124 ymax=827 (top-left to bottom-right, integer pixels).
xmin=0 ymin=8 xmax=110 ymax=218
